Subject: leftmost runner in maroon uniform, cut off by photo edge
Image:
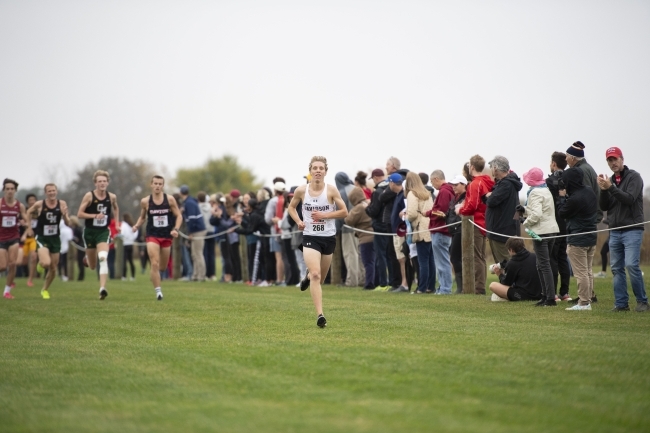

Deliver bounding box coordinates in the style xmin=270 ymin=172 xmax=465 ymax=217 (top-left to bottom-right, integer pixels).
xmin=0 ymin=179 xmax=26 ymax=299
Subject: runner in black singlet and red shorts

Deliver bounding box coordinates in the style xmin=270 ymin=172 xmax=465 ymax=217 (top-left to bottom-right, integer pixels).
xmin=133 ymin=175 xmax=183 ymax=301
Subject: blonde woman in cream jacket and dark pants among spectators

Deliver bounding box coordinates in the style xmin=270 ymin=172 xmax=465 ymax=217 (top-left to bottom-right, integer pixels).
xmin=405 ymin=172 xmax=436 ymax=294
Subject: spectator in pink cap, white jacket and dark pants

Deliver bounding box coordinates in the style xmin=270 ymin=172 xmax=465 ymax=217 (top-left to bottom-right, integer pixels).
xmin=524 ymin=167 xmax=560 ymax=307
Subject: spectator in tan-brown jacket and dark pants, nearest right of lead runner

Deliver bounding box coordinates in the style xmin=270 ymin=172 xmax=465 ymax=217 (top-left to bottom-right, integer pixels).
xmin=345 ymin=185 xmax=375 ymax=290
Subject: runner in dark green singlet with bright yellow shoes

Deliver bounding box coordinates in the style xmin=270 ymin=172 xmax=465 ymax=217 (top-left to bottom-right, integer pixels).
xmin=27 ymin=183 xmax=70 ymax=299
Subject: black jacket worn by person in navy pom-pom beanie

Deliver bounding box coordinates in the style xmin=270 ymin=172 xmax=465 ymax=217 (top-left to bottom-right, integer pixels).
xmin=557 ymin=167 xmax=598 ymax=247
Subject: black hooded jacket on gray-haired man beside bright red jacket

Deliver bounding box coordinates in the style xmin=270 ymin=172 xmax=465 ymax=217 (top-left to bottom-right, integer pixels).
xmin=485 ymin=171 xmax=522 ymax=243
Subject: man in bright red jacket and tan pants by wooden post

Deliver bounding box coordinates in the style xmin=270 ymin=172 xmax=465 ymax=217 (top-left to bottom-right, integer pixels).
xmin=456 ymin=155 xmax=494 ymax=295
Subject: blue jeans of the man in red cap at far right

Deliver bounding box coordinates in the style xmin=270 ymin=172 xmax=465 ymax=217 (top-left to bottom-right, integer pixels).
xmin=609 ymin=230 xmax=648 ymax=307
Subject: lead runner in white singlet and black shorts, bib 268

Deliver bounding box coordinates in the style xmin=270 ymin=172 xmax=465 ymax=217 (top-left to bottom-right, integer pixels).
xmin=289 ymin=156 xmax=348 ymax=328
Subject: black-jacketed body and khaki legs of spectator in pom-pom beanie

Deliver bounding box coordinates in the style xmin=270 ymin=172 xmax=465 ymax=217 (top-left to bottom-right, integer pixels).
xmin=558 ymin=168 xmax=598 ymax=310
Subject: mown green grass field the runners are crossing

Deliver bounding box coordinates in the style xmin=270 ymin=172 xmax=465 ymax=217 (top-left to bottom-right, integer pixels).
xmin=0 ymin=276 xmax=650 ymax=433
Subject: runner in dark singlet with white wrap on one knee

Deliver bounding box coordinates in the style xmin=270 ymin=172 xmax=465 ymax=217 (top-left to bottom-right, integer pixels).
xmin=77 ymin=170 xmax=120 ymax=300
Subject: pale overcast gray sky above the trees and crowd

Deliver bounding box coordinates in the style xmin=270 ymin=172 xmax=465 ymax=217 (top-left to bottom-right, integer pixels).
xmin=0 ymin=0 xmax=650 ymax=192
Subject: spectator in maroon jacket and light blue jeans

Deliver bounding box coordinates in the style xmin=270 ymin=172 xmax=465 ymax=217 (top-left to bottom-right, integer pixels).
xmin=429 ymin=170 xmax=454 ymax=295
